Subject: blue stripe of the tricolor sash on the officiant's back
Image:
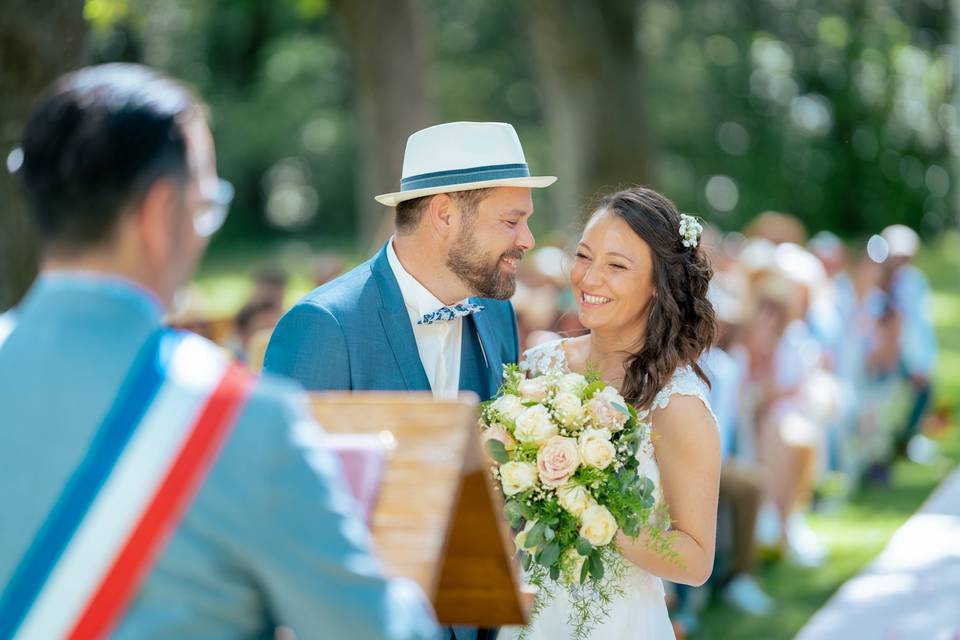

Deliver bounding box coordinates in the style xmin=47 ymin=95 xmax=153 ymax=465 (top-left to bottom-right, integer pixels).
xmin=0 ymin=329 xmax=183 ymax=640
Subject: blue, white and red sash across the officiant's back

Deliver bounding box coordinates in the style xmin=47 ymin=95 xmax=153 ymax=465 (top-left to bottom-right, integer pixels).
xmin=0 ymin=329 xmax=253 ymax=640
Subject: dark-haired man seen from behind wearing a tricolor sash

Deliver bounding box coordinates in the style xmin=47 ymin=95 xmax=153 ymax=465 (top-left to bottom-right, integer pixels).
xmin=0 ymin=64 xmax=436 ymax=638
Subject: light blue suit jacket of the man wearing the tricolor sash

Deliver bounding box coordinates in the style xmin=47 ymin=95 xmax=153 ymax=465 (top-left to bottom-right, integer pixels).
xmin=0 ymin=276 xmax=437 ymax=639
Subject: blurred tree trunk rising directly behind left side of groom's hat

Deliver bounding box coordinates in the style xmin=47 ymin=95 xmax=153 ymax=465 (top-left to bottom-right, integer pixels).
xmin=332 ymin=0 xmax=434 ymax=252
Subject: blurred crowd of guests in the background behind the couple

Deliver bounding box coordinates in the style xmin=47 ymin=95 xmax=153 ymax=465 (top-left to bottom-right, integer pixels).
xmin=176 ymin=212 xmax=937 ymax=635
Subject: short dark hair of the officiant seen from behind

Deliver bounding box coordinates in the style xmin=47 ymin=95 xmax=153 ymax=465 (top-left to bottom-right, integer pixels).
xmin=19 ymin=64 xmax=203 ymax=252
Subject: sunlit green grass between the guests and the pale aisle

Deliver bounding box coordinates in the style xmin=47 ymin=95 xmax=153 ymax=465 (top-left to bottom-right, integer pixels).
xmin=690 ymin=234 xmax=960 ymax=640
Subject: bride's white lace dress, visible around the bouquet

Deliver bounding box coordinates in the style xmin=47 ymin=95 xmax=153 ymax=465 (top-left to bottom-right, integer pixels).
xmin=497 ymin=340 xmax=716 ymax=640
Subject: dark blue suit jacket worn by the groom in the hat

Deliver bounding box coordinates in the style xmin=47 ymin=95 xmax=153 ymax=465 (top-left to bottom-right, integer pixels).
xmin=264 ymin=245 xmax=519 ymax=400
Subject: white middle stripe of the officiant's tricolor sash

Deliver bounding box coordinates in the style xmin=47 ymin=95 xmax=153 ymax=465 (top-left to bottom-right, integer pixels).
xmin=17 ymin=335 xmax=227 ymax=638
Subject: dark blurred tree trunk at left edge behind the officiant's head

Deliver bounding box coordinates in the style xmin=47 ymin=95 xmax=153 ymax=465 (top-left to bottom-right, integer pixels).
xmin=0 ymin=0 xmax=86 ymax=312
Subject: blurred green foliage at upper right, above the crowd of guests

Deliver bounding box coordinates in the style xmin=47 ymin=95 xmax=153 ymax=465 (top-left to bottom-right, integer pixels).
xmin=640 ymin=0 xmax=958 ymax=235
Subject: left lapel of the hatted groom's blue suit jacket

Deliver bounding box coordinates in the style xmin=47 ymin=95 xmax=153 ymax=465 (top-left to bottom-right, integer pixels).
xmin=373 ymin=246 xmax=430 ymax=391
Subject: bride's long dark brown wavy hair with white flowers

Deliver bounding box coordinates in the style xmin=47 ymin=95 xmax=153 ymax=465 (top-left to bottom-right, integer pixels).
xmin=594 ymin=187 xmax=717 ymax=408
